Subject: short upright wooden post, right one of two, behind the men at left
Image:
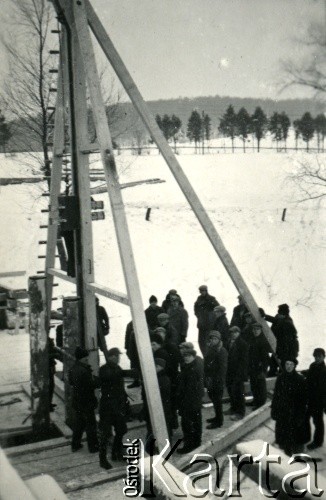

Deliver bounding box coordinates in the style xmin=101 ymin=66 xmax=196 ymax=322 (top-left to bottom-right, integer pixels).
xmin=62 ymin=297 xmax=83 ymax=427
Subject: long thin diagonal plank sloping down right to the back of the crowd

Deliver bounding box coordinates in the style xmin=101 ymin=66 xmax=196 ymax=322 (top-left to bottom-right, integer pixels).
xmin=84 ymin=0 xmax=276 ymax=352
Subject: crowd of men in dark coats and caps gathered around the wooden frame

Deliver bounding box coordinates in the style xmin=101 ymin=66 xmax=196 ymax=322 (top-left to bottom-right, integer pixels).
xmin=67 ymin=285 xmax=326 ymax=469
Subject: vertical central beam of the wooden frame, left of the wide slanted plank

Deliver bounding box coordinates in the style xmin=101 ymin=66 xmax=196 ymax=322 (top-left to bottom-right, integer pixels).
xmin=68 ymin=11 xmax=99 ymax=375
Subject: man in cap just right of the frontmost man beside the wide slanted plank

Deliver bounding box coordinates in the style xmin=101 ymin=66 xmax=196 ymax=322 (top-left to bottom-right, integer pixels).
xmin=204 ymin=330 xmax=228 ymax=429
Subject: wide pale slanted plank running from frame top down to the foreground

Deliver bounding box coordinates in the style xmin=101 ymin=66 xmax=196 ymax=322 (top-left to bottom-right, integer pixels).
xmin=73 ymin=2 xmax=168 ymax=449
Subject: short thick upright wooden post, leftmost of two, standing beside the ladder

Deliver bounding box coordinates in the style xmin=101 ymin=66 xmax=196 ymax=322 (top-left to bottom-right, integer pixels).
xmin=28 ymin=276 xmax=50 ymax=434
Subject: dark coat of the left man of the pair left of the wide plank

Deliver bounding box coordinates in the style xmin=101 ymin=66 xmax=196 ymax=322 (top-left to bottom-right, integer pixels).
xmin=68 ymin=361 xmax=97 ymax=411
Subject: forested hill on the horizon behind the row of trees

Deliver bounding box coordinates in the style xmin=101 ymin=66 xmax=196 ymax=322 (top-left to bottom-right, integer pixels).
xmin=114 ymin=95 xmax=326 ymax=136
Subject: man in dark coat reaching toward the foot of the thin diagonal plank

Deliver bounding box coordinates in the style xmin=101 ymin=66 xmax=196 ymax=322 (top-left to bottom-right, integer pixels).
xmin=260 ymin=304 xmax=299 ymax=376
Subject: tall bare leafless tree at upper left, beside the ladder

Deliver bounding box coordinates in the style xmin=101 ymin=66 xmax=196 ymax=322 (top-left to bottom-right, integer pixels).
xmin=1 ymin=0 xmax=58 ymax=180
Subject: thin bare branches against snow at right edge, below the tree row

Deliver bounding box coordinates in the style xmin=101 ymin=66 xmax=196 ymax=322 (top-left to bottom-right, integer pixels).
xmin=287 ymin=155 xmax=326 ymax=203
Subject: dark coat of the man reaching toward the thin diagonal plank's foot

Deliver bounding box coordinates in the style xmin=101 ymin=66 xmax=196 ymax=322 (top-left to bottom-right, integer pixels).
xmin=265 ymin=314 xmax=299 ymax=363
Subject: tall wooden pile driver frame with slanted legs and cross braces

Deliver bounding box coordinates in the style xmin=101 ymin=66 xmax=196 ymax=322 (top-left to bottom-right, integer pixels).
xmin=35 ymin=0 xmax=275 ymax=450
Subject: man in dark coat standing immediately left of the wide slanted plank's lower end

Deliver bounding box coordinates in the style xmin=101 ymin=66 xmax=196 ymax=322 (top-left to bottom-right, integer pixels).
xmin=99 ymin=347 xmax=128 ymax=469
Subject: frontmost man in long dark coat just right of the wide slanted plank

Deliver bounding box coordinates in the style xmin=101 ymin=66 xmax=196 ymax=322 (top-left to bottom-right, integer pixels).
xmin=177 ymin=351 xmax=204 ymax=454
